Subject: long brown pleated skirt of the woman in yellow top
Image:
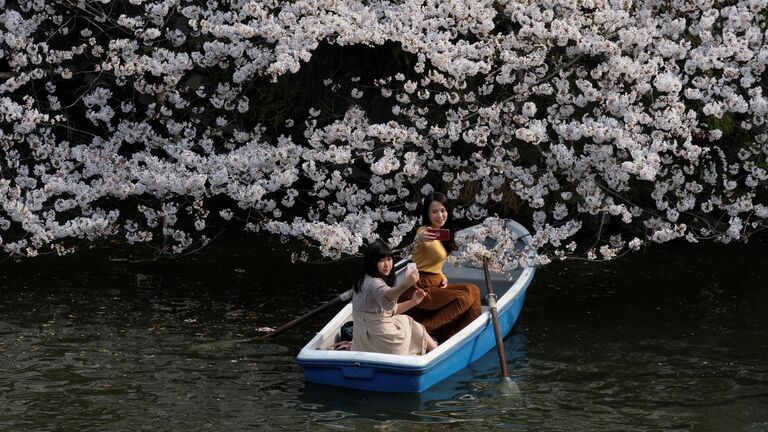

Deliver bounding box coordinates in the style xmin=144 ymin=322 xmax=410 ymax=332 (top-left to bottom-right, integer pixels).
xmin=399 ymin=272 xmax=480 ymax=340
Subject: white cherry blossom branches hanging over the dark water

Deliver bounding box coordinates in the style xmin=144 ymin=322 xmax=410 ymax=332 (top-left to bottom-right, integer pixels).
xmin=0 ymin=0 xmax=768 ymax=266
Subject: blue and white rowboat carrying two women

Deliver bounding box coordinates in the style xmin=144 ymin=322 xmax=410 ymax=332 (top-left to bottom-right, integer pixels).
xmin=297 ymin=220 xmax=536 ymax=393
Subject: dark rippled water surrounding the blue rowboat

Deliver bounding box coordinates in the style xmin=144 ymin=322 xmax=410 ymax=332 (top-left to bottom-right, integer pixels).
xmin=0 ymin=239 xmax=768 ymax=432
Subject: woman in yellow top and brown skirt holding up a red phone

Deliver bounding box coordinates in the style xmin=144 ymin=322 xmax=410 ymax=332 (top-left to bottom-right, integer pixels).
xmin=400 ymin=192 xmax=480 ymax=340
